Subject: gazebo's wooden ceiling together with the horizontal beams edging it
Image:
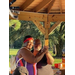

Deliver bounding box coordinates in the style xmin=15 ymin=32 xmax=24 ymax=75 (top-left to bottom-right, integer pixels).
xmin=9 ymin=0 xmax=65 ymax=22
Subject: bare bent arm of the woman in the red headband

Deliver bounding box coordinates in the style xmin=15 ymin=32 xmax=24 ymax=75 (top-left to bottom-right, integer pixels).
xmin=20 ymin=48 xmax=47 ymax=63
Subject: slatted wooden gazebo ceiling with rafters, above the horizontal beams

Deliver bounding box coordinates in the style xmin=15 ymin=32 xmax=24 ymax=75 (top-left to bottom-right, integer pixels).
xmin=9 ymin=0 xmax=65 ymax=14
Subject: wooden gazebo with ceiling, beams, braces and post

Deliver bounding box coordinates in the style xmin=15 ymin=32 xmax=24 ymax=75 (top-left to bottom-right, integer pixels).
xmin=9 ymin=0 xmax=65 ymax=45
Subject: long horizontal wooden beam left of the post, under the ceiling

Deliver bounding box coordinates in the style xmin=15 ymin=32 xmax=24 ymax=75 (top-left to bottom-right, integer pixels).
xmin=9 ymin=11 xmax=47 ymax=21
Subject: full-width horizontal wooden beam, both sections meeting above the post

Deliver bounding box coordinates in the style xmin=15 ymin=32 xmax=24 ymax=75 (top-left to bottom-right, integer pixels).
xmin=9 ymin=11 xmax=65 ymax=22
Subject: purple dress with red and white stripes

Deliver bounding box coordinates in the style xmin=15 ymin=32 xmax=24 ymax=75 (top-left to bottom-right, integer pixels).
xmin=16 ymin=57 xmax=37 ymax=75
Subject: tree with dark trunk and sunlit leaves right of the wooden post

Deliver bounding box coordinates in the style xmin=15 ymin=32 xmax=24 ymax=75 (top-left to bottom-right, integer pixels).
xmin=49 ymin=22 xmax=65 ymax=57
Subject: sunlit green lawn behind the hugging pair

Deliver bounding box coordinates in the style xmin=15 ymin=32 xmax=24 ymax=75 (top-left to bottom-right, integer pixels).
xmin=9 ymin=49 xmax=62 ymax=67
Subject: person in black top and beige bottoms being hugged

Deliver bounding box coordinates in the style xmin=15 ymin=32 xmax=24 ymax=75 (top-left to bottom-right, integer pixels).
xmin=32 ymin=39 xmax=54 ymax=75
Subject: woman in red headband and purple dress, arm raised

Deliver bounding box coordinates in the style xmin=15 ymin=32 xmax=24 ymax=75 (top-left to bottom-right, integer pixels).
xmin=16 ymin=36 xmax=48 ymax=75
